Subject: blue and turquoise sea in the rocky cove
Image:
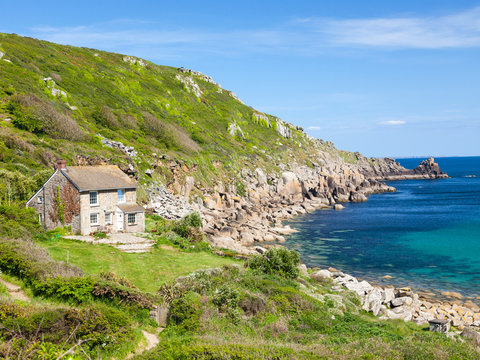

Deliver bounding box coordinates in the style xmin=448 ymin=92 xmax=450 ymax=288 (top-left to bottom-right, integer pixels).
xmin=285 ymin=157 xmax=480 ymax=297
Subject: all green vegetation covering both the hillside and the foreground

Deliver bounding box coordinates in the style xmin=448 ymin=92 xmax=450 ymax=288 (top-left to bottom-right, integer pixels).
xmin=0 ymin=34 xmax=480 ymax=359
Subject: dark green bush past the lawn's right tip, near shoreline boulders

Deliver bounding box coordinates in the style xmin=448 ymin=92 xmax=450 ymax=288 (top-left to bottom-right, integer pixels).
xmin=247 ymin=248 xmax=300 ymax=279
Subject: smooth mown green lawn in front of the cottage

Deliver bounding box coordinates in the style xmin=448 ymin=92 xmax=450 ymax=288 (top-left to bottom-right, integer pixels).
xmin=38 ymin=238 xmax=240 ymax=293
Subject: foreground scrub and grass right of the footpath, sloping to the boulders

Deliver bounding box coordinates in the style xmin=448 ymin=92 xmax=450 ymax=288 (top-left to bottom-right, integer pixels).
xmin=136 ymin=262 xmax=480 ymax=359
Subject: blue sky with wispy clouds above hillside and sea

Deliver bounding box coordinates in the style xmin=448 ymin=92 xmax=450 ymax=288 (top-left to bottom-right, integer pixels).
xmin=0 ymin=0 xmax=480 ymax=157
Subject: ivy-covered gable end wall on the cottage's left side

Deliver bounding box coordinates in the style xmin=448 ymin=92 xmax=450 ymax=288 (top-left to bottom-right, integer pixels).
xmin=28 ymin=171 xmax=80 ymax=232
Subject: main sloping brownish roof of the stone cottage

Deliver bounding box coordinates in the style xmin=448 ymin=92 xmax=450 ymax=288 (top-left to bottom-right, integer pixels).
xmin=61 ymin=165 xmax=137 ymax=191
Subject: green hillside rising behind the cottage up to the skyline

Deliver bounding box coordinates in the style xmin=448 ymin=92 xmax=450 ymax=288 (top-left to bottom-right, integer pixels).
xmin=0 ymin=34 xmax=333 ymax=200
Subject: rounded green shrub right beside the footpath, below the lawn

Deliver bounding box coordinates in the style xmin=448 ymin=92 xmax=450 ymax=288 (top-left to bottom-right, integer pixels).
xmin=170 ymin=291 xmax=202 ymax=331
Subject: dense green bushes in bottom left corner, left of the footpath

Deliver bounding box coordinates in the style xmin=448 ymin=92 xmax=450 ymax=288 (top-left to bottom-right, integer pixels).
xmin=0 ymin=303 xmax=133 ymax=359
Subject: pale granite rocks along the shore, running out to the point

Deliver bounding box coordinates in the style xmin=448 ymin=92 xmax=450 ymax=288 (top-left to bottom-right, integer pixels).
xmin=189 ymin=153 xmax=448 ymax=254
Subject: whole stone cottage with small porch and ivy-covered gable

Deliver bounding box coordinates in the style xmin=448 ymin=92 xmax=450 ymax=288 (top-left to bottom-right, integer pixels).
xmin=27 ymin=160 xmax=145 ymax=235
